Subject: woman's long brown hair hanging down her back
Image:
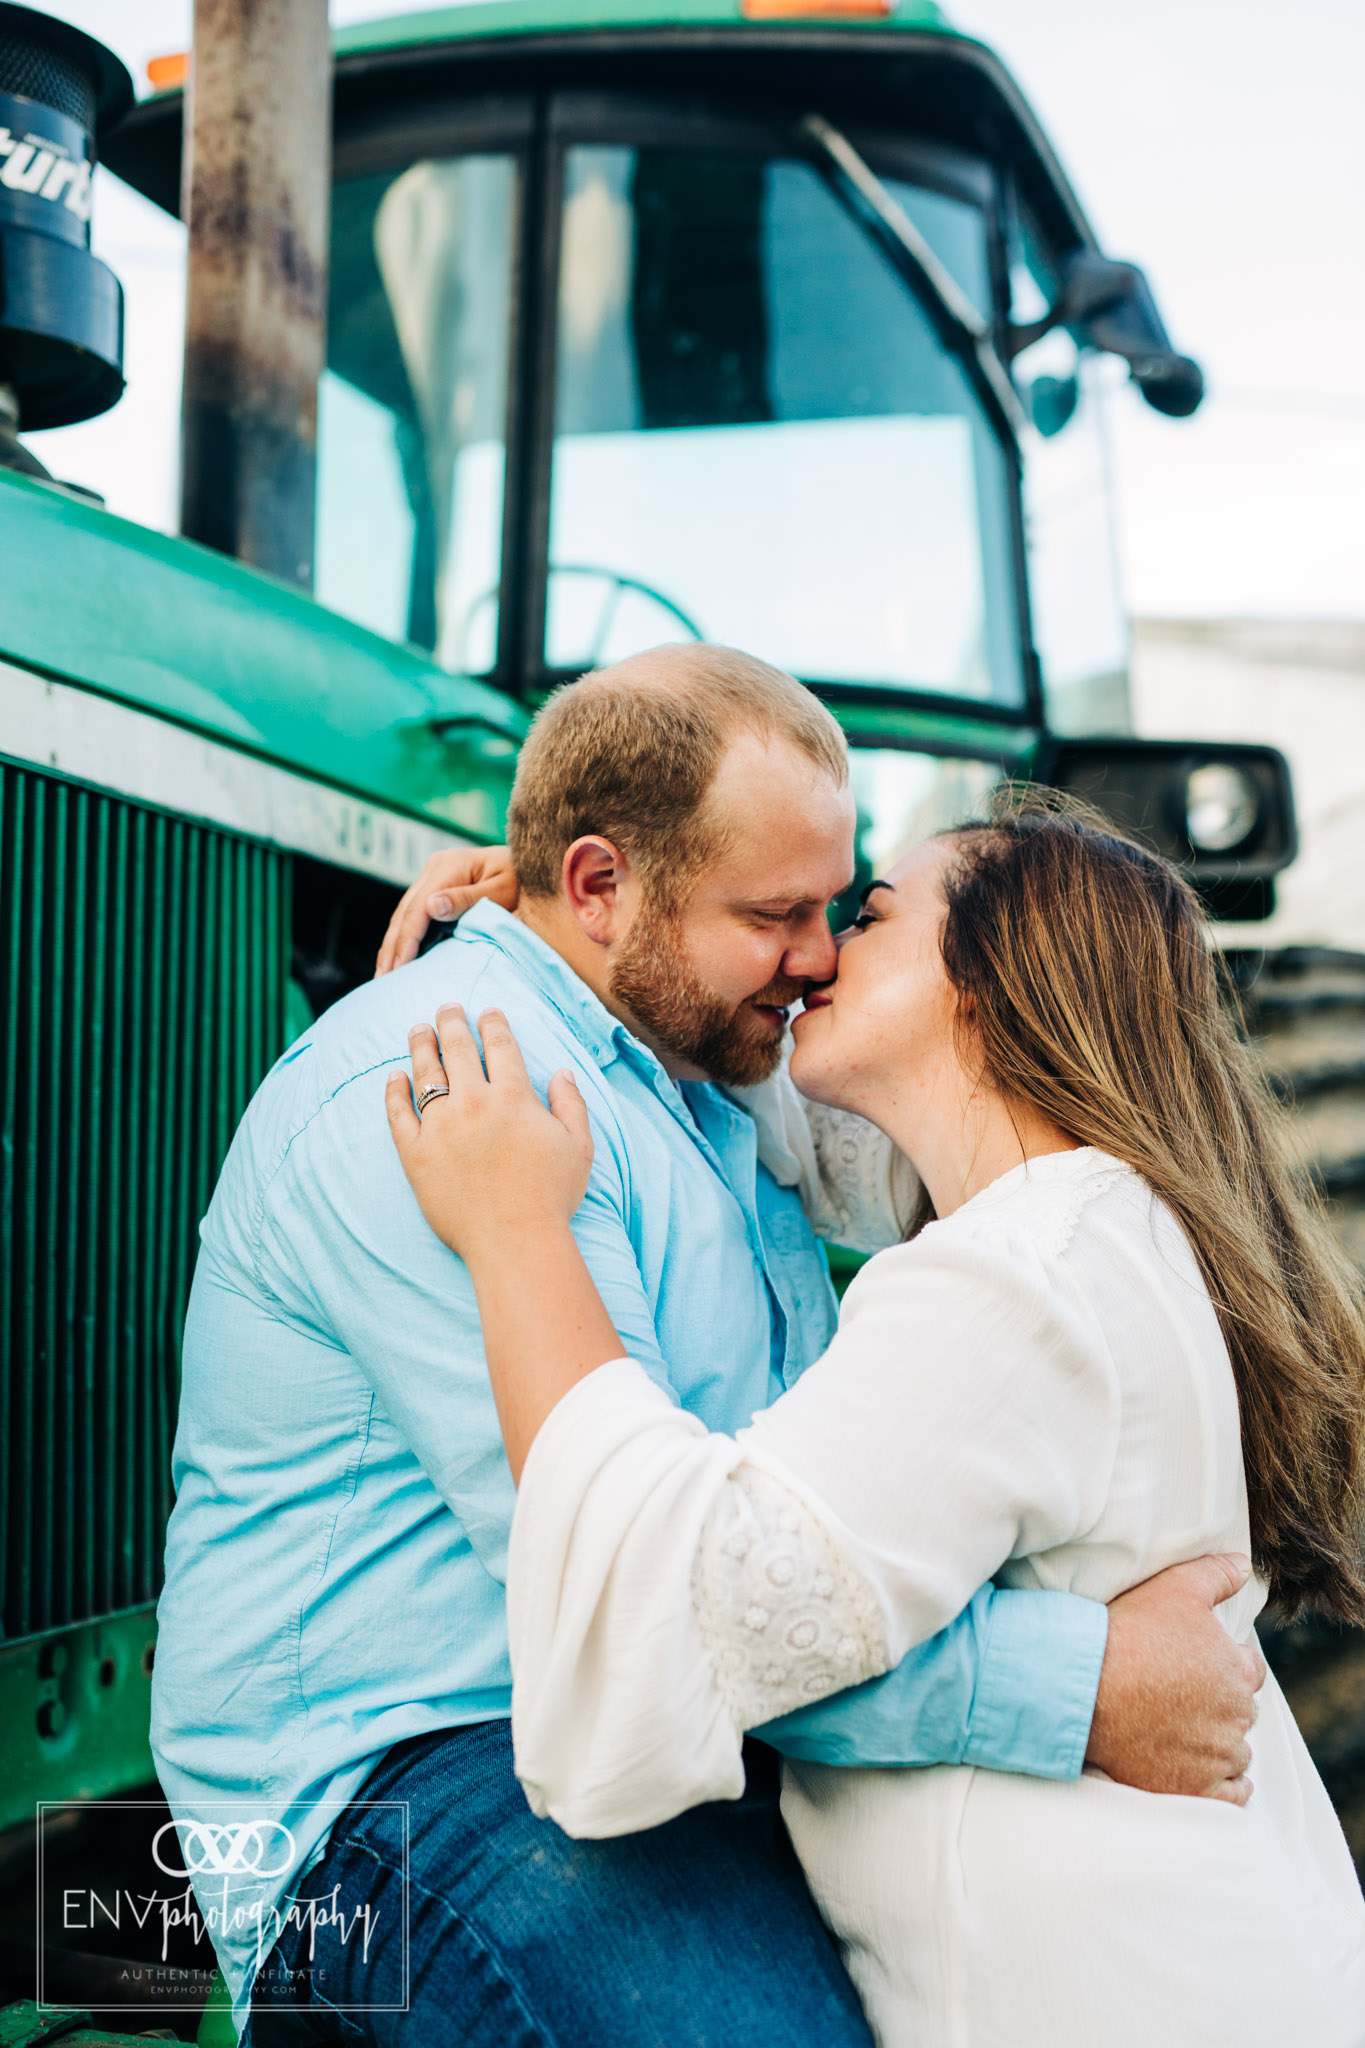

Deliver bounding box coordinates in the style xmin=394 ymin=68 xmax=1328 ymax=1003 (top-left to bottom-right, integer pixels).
xmin=941 ymin=791 xmax=1365 ymax=1622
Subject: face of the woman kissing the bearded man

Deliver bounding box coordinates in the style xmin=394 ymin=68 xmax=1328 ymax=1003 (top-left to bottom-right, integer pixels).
xmin=792 ymin=840 xmax=962 ymax=1122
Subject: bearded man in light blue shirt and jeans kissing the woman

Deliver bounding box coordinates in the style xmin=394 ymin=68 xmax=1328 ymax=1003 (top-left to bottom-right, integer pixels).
xmin=153 ymin=647 xmax=1261 ymax=2048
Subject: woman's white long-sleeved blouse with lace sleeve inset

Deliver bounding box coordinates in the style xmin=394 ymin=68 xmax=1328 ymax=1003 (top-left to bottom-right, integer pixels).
xmin=508 ymin=1139 xmax=1365 ymax=2048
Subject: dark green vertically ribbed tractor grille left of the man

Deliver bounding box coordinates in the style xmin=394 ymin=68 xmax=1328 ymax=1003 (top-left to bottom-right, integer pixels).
xmin=0 ymin=764 xmax=289 ymax=1638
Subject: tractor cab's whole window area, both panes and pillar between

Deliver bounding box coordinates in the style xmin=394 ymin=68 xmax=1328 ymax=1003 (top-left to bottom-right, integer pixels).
xmin=317 ymin=123 xmax=1025 ymax=709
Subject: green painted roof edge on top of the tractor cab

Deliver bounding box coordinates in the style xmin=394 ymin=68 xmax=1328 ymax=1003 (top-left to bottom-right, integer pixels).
xmin=332 ymin=0 xmax=958 ymax=57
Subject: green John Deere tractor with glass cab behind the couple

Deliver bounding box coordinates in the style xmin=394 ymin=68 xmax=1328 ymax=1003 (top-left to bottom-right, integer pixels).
xmin=0 ymin=0 xmax=1342 ymax=2040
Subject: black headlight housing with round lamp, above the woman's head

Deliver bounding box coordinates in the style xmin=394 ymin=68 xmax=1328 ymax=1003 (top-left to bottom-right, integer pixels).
xmin=1036 ymin=739 xmax=1297 ymax=920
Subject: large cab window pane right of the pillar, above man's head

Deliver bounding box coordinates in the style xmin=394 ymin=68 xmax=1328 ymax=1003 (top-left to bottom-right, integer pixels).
xmin=544 ymin=147 xmax=1021 ymax=702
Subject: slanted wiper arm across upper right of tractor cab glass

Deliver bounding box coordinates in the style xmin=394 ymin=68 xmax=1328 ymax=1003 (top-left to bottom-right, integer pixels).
xmin=800 ymin=115 xmax=1023 ymax=449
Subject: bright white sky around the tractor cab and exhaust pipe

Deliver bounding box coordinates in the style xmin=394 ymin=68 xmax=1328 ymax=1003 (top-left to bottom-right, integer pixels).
xmin=33 ymin=0 xmax=1365 ymax=618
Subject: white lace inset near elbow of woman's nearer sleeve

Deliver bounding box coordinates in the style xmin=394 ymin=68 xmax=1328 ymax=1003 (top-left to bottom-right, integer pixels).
xmin=692 ymin=1464 xmax=890 ymax=1729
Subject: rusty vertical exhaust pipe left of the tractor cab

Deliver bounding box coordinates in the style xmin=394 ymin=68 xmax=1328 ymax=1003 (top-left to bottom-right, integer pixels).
xmin=180 ymin=0 xmax=332 ymax=590
